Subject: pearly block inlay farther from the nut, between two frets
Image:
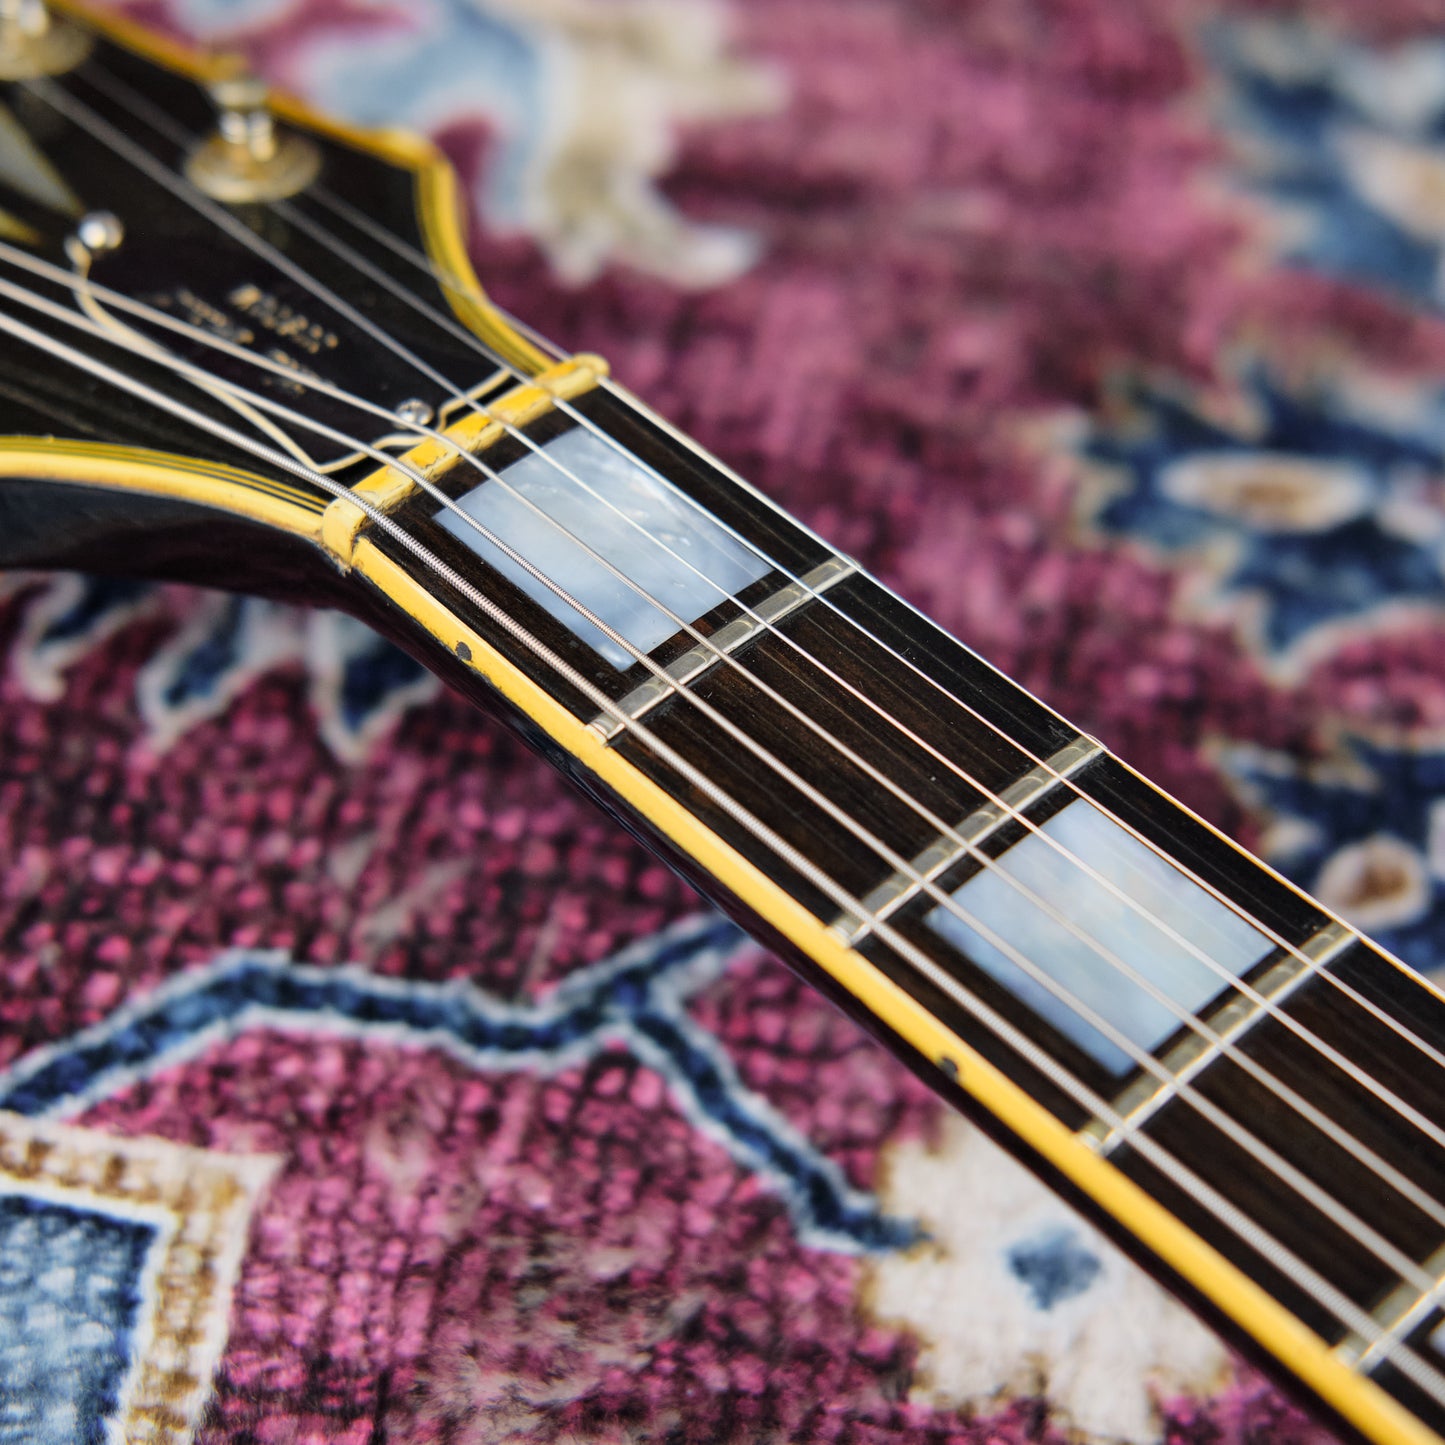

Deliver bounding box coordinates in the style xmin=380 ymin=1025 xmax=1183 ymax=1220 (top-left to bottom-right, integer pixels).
xmin=928 ymin=798 xmax=1273 ymax=1077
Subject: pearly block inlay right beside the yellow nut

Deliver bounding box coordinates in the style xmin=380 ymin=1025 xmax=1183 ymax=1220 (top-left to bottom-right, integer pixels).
xmin=436 ymin=426 xmax=772 ymax=668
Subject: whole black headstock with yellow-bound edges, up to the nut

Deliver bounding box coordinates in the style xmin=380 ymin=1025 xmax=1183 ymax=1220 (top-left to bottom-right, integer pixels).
xmin=0 ymin=0 xmax=565 ymax=591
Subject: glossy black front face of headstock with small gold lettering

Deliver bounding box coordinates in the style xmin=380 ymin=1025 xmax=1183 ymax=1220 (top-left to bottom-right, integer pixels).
xmin=0 ymin=1 xmax=545 ymax=525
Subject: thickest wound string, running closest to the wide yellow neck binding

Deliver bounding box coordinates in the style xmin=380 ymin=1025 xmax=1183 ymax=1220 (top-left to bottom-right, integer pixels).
xmin=8 ymin=287 xmax=1445 ymax=1400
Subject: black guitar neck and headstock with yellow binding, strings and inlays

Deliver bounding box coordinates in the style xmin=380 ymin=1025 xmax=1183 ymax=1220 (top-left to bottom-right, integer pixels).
xmin=0 ymin=4 xmax=1445 ymax=1442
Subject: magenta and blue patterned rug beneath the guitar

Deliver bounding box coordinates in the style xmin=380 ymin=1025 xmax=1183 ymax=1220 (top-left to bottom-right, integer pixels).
xmin=0 ymin=0 xmax=1445 ymax=1445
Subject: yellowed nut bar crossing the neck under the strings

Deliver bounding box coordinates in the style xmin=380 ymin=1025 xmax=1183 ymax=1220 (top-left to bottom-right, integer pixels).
xmin=321 ymin=354 xmax=607 ymax=569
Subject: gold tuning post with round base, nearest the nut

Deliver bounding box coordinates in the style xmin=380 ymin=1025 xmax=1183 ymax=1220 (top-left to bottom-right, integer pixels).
xmin=184 ymin=77 xmax=321 ymax=205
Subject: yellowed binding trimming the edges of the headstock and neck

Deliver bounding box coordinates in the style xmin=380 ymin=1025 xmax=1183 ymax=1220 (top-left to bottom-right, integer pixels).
xmin=0 ymin=14 xmax=1445 ymax=1445
